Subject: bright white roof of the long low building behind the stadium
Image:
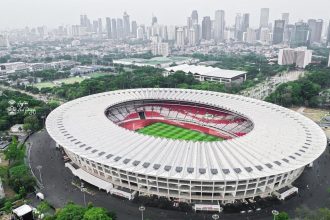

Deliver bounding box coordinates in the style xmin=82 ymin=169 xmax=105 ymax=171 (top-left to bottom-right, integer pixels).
xmin=166 ymin=64 xmax=246 ymax=79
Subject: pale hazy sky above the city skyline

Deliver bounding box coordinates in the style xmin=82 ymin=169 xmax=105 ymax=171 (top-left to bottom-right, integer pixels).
xmin=0 ymin=0 xmax=330 ymax=29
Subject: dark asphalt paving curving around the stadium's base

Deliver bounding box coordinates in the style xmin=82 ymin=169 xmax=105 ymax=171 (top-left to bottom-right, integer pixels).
xmin=29 ymin=131 xmax=330 ymax=220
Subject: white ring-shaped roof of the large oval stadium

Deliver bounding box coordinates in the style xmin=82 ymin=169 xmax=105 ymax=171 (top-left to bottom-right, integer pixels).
xmin=46 ymin=89 xmax=326 ymax=181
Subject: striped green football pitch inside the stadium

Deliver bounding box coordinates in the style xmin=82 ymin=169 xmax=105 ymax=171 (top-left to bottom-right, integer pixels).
xmin=137 ymin=122 xmax=223 ymax=141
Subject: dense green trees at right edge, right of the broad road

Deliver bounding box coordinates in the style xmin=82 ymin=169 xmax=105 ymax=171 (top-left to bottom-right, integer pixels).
xmin=266 ymin=66 xmax=330 ymax=107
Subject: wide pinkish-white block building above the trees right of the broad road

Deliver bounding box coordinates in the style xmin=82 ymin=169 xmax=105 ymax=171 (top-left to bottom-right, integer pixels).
xmin=278 ymin=47 xmax=313 ymax=68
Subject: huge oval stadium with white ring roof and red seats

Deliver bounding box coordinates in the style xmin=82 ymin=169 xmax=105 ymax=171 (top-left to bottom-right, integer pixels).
xmin=46 ymin=88 xmax=326 ymax=204
